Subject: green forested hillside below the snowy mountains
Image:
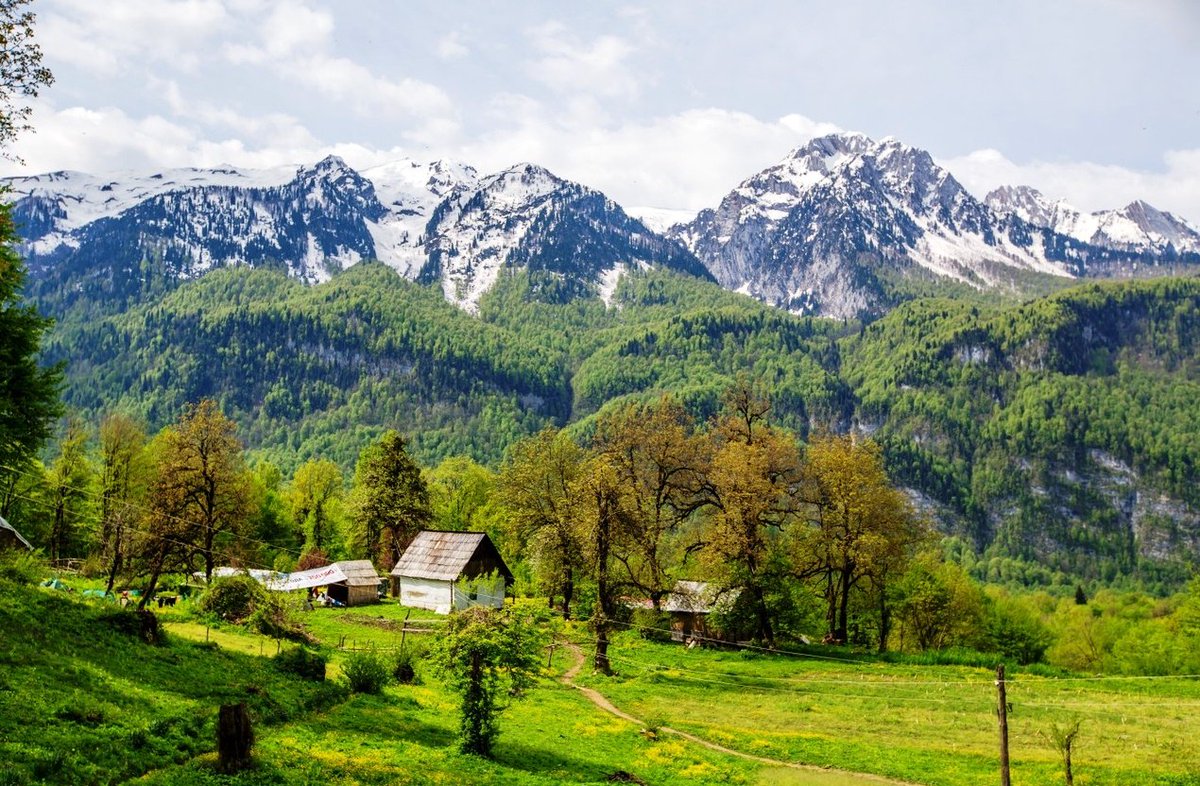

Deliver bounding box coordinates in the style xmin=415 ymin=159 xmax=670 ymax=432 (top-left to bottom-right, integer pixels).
xmin=32 ymin=264 xmax=1200 ymax=582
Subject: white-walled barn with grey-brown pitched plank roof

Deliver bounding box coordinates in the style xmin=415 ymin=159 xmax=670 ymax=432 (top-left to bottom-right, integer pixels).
xmin=391 ymin=529 xmax=512 ymax=614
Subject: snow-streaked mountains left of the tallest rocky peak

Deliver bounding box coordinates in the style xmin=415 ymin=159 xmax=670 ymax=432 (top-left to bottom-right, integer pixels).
xmin=11 ymin=156 xmax=708 ymax=311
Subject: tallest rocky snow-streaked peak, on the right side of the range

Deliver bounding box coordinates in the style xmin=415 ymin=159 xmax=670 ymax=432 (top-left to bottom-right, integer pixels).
xmin=672 ymin=133 xmax=1180 ymax=318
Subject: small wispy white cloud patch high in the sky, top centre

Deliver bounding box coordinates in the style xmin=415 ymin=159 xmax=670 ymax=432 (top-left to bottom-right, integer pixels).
xmin=526 ymin=22 xmax=640 ymax=98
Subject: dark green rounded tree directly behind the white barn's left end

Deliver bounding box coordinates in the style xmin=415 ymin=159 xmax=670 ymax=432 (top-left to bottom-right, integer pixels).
xmin=350 ymin=431 xmax=433 ymax=569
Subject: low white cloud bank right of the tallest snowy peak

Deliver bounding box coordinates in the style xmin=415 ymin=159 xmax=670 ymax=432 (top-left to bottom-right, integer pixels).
xmin=938 ymin=149 xmax=1200 ymax=227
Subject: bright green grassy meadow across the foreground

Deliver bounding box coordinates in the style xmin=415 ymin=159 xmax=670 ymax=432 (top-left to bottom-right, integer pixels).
xmin=9 ymin=583 xmax=1200 ymax=786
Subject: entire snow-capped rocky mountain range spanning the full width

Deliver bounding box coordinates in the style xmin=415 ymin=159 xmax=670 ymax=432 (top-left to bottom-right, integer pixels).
xmin=7 ymin=133 xmax=1200 ymax=318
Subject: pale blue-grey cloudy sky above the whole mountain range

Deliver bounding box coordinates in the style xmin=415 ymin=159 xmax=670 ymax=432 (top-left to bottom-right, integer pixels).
xmin=9 ymin=0 xmax=1200 ymax=226
